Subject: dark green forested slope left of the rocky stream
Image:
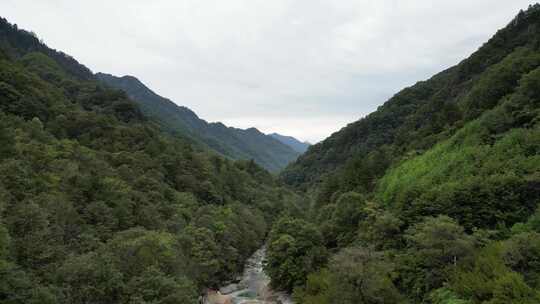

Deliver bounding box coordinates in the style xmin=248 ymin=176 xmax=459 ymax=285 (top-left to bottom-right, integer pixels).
xmin=0 ymin=19 xmax=298 ymax=304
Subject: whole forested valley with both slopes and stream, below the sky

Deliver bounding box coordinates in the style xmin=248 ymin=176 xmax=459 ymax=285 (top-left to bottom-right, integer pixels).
xmin=0 ymin=4 xmax=540 ymax=304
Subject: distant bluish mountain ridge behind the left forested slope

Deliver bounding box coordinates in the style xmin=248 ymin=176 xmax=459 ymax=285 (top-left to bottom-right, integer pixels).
xmin=96 ymin=73 xmax=300 ymax=172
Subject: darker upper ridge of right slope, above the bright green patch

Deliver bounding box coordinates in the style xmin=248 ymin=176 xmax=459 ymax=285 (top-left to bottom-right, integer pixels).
xmin=282 ymin=4 xmax=540 ymax=188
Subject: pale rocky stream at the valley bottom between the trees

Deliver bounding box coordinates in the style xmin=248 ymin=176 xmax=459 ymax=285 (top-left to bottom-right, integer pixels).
xmin=205 ymin=247 xmax=293 ymax=304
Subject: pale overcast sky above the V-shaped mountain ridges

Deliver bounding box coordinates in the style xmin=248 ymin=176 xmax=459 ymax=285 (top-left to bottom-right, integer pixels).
xmin=0 ymin=0 xmax=534 ymax=142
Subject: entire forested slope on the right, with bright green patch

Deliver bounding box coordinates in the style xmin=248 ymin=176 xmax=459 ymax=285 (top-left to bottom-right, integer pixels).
xmin=266 ymin=4 xmax=540 ymax=304
